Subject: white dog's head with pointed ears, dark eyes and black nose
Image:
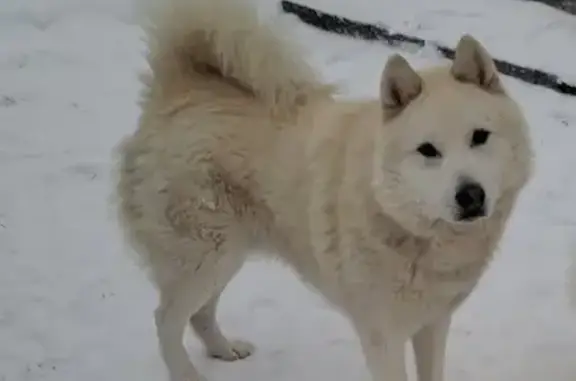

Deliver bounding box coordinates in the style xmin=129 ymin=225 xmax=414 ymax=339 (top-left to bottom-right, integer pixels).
xmin=374 ymin=36 xmax=532 ymax=235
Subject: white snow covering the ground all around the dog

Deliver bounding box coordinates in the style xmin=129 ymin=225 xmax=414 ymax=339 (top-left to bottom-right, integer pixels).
xmin=0 ymin=0 xmax=576 ymax=381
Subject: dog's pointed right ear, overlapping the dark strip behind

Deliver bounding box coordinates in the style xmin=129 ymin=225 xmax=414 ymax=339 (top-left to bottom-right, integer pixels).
xmin=450 ymin=34 xmax=504 ymax=93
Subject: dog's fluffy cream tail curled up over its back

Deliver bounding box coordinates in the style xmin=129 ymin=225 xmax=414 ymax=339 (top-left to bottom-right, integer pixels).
xmin=139 ymin=0 xmax=333 ymax=114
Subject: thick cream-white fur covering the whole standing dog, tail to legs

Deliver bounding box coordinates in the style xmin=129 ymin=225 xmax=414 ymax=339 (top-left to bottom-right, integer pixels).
xmin=118 ymin=0 xmax=532 ymax=381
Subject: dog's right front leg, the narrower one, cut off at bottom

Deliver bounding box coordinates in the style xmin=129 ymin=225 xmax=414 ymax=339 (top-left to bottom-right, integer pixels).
xmin=412 ymin=315 xmax=451 ymax=381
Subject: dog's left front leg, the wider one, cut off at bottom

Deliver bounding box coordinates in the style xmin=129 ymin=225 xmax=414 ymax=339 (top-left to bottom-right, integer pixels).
xmin=358 ymin=328 xmax=408 ymax=381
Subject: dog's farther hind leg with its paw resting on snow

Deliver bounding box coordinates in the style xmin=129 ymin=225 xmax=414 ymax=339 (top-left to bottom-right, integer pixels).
xmin=190 ymin=294 xmax=254 ymax=361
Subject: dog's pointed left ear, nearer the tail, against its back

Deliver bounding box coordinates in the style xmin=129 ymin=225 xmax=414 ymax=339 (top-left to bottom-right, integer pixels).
xmin=380 ymin=54 xmax=423 ymax=116
